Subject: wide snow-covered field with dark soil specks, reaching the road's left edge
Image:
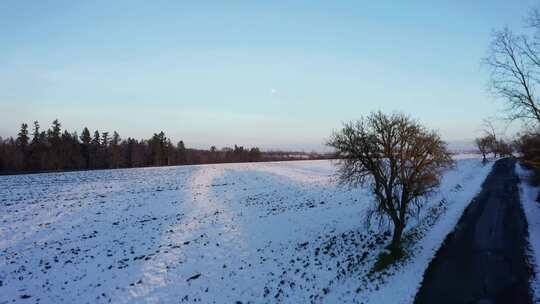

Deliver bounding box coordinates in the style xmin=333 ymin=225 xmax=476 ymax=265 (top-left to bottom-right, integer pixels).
xmin=0 ymin=158 xmax=491 ymax=303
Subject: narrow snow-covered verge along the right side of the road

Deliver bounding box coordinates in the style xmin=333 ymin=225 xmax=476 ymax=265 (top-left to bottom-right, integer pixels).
xmin=516 ymin=164 xmax=540 ymax=303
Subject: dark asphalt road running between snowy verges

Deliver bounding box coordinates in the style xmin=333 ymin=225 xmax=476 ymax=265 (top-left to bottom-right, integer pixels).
xmin=415 ymin=158 xmax=532 ymax=304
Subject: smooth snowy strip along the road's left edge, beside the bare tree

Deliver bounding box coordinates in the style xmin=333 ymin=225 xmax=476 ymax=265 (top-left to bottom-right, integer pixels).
xmin=326 ymin=160 xmax=494 ymax=304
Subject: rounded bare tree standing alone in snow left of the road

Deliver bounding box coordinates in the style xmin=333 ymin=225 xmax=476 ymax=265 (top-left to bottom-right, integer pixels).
xmin=327 ymin=112 xmax=453 ymax=257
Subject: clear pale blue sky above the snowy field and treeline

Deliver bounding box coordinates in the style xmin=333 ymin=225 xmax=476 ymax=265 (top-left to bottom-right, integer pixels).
xmin=0 ymin=0 xmax=536 ymax=148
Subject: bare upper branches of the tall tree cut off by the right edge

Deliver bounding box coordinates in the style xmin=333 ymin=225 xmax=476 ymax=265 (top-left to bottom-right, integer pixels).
xmin=484 ymin=10 xmax=540 ymax=123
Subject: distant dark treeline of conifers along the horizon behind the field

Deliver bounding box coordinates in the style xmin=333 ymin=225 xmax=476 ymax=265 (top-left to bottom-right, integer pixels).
xmin=0 ymin=120 xmax=329 ymax=174
